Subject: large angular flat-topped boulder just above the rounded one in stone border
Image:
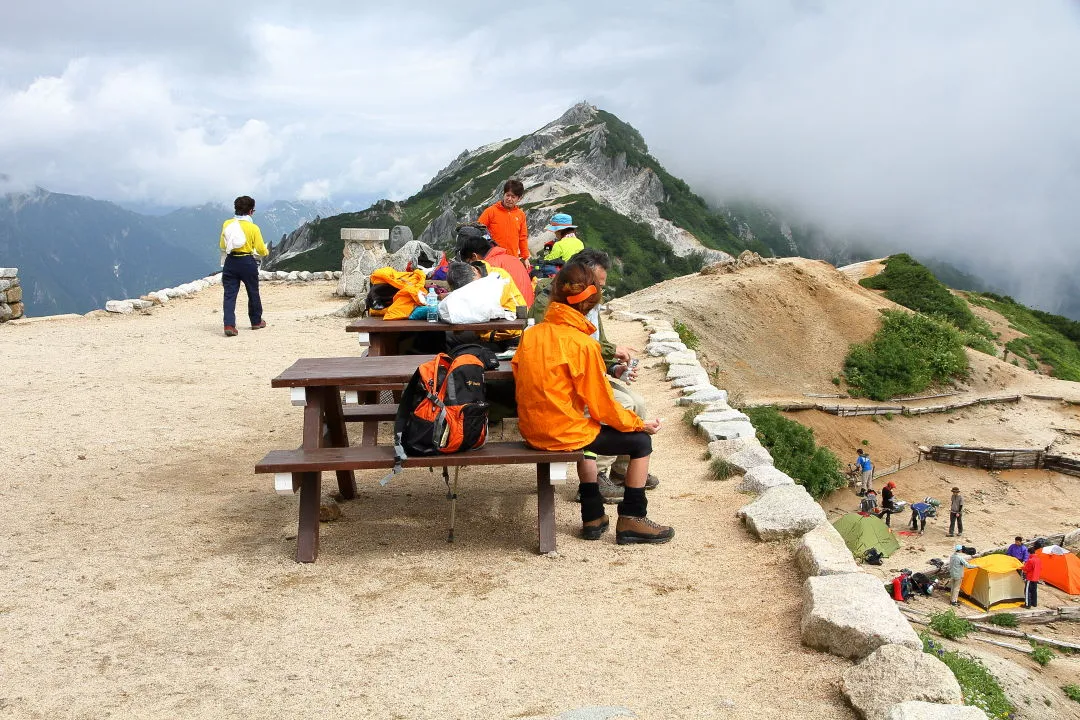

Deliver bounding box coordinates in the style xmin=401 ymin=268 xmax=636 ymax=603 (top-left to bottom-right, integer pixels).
xmin=803 ymin=574 xmax=922 ymax=660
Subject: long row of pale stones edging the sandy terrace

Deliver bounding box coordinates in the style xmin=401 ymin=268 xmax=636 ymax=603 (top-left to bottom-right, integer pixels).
xmin=611 ymin=310 xmax=985 ymax=720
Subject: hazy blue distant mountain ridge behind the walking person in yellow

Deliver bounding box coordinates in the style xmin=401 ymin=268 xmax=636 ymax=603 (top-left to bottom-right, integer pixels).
xmin=0 ymin=188 xmax=334 ymax=317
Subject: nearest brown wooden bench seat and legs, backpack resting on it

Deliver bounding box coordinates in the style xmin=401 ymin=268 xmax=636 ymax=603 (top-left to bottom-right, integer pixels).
xmin=255 ymin=440 xmax=582 ymax=562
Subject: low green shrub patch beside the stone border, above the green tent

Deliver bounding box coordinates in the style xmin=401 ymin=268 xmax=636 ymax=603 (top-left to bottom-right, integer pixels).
xmin=744 ymin=406 xmax=847 ymax=500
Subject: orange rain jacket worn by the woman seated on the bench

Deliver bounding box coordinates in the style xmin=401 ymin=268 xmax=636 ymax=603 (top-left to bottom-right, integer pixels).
xmin=511 ymin=302 xmax=645 ymax=450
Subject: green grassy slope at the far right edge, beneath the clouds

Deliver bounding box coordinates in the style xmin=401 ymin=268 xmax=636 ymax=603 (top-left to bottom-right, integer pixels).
xmin=968 ymin=293 xmax=1080 ymax=381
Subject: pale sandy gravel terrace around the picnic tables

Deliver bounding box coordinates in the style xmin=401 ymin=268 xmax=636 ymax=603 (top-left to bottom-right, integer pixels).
xmin=0 ymin=283 xmax=853 ymax=720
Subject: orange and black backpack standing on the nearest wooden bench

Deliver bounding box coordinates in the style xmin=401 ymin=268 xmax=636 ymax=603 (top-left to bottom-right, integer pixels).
xmin=394 ymin=345 xmax=499 ymax=472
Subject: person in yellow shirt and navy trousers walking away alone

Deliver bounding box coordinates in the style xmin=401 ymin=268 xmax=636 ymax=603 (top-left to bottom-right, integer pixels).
xmin=218 ymin=195 xmax=270 ymax=338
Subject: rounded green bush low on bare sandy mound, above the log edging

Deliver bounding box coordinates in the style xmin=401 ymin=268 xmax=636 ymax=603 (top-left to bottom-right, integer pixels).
xmin=843 ymin=310 xmax=968 ymax=400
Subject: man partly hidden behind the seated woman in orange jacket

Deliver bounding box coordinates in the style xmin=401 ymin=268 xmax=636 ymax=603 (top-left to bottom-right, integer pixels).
xmin=531 ymin=248 xmax=660 ymax=503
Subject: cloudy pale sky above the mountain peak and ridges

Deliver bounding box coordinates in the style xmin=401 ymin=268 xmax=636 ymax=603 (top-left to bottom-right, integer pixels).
xmin=0 ymin=0 xmax=1080 ymax=306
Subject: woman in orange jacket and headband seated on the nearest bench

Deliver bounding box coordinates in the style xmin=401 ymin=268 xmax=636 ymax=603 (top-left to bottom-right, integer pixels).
xmin=512 ymin=262 xmax=675 ymax=545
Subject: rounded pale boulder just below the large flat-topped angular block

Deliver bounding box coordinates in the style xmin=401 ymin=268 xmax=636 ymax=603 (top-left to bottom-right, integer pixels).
xmin=840 ymin=644 xmax=963 ymax=720
